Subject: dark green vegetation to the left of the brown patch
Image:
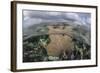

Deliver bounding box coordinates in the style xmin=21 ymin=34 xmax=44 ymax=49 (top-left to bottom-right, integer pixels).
xmin=23 ymin=35 xmax=50 ymax=62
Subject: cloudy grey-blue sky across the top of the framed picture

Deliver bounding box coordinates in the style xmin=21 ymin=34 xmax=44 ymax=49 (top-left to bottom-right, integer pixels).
xmin=23 ymin=10 xmax=91 ymax=27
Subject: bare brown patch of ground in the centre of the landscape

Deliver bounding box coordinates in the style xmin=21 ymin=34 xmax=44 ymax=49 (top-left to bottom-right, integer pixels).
xmin=47 ymin=26 xmax=73 ymax=56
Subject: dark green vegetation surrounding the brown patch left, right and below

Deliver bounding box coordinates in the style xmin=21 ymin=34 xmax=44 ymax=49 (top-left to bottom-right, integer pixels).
xmin=23 ymin=35 xmax=90 ymax=62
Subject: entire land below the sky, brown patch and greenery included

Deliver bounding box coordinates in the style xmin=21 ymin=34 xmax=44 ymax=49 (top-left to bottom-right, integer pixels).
xmin=23 ymin=22 xmax=91 ymax=62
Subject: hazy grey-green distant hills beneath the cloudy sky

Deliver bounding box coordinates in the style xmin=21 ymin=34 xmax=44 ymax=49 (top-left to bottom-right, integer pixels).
xmin=23 ymin=22 xmax=91 ymax=44
